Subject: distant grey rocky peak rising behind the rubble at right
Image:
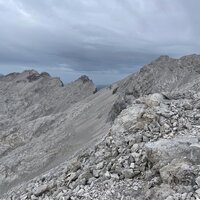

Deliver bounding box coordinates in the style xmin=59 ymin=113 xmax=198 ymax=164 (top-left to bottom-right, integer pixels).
xmin=118 ymin=55 xmax=200 ymax=97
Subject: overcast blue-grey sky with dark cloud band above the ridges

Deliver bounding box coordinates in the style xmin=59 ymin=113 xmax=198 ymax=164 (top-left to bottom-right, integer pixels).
xmin=0 ymin=0 xmax=200 ymax=84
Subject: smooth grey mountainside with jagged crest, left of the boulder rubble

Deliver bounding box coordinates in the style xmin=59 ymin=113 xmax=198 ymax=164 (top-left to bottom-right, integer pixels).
xmin=0 ymin=71 xmax=119 ymax=193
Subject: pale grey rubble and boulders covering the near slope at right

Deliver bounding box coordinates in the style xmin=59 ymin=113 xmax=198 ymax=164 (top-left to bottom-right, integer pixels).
xmin=5 ymin=92 xmax=200 ymax=200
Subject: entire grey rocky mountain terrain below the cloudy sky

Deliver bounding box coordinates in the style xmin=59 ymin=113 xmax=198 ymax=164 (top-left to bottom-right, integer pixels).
xmin=0 ymin=55 xmax=200 ymax=200
